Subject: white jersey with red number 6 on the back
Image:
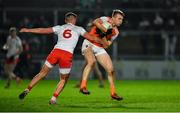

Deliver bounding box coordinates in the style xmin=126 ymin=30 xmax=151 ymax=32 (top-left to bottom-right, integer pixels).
xmin=53 ymin=23 xmax=86 ymax=54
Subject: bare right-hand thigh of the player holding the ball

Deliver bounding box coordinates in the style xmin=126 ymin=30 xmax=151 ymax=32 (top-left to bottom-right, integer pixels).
xmin=96 ymin=53 xmax=113 ymax=71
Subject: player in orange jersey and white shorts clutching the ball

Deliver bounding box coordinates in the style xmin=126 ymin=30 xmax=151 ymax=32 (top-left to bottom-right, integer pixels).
xmin=80 ymin=10 xmax=124 ymax=100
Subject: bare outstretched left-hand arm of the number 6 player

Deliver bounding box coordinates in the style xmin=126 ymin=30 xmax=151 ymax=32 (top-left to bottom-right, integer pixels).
xmin=20 ymin=27 xmax=54 ymax=34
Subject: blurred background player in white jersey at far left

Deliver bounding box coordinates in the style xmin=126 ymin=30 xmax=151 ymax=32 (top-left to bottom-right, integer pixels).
xmin=3 ymin=27 xmax=23 ymax=88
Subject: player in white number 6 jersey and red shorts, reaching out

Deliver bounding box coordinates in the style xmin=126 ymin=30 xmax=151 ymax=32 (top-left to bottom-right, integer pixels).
xmin=19 ymin=12 xmax=107 ymax=104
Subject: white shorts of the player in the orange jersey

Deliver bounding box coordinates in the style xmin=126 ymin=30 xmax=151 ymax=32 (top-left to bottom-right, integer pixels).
xmin=81 ymin=39 xmax=107 ymax=56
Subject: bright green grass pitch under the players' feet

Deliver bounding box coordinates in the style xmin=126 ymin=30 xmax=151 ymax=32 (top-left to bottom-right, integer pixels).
xmin=0 ymin=80 xmax=180 ymax=112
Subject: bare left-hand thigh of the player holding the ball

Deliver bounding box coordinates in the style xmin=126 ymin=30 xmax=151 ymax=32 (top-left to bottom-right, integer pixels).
xmin=83 ymin=47 xmax=96 ymax=63
